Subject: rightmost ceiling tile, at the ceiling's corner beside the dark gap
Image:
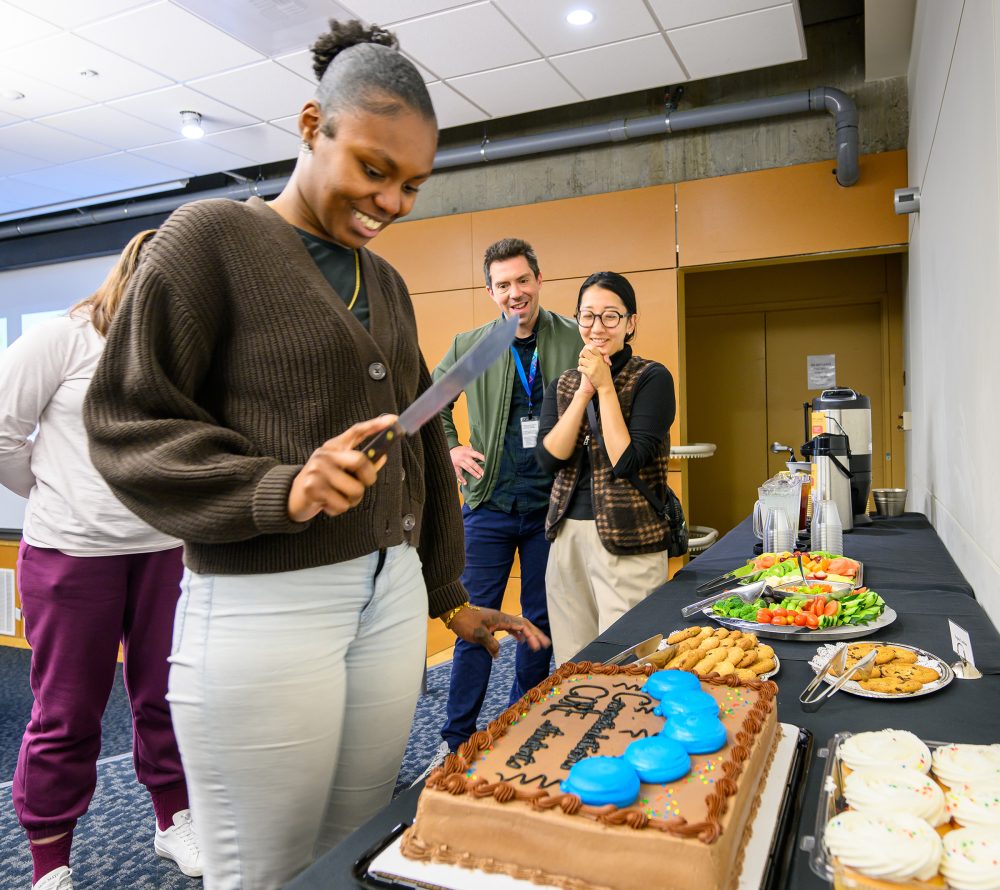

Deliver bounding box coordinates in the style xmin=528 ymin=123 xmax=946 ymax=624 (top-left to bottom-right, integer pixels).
xmin=667 ymin=5 xmax=806 ymax=80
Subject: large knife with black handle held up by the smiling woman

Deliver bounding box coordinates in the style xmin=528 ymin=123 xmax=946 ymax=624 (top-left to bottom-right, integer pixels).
xmin=361 ymin=315 xmax=520 ymax=461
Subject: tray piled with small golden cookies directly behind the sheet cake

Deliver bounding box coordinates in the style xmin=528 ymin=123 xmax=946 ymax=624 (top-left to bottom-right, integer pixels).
xmin=636 ymin=627 xmax=781 ymax=680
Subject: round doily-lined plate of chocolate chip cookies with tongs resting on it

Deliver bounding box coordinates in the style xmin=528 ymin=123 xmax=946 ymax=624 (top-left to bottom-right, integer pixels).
xmin=809 ymin=641 xmax=955 ymax=699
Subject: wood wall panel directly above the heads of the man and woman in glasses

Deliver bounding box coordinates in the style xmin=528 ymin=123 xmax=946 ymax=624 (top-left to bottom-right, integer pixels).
xmin=472 ymin=185 xmax=676 ymax=279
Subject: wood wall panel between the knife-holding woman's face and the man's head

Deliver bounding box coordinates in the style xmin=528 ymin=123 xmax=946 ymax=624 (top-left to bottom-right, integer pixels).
xmin=372 ymin=213 xmax=474 ymax=294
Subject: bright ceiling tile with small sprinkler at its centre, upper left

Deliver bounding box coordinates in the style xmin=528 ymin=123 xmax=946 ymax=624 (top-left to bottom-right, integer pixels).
xmin=4 ymin=33 xmax=172 ymax=102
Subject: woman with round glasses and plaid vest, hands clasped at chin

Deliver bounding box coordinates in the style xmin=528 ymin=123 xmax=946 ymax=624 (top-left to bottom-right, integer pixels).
xmin=535 ymin=272 xmax=675 ymax=664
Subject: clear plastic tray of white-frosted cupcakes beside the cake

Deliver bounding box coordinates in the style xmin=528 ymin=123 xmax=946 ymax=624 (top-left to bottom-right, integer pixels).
xmin=802 ymin=729 xmax=1000 ymax=890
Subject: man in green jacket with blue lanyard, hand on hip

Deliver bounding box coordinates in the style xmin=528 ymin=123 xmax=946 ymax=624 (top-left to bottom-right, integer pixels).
xmin=434 ymin=238 xmax=583 ymax=751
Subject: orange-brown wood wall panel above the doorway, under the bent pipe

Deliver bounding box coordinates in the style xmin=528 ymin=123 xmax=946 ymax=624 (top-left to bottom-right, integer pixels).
xmin=677 ymin=151 xmax=908 ymax=266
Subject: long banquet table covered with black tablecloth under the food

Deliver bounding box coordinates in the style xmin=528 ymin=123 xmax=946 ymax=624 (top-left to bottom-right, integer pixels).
xmin=288 ymin=513 xmax=1000 ymax=890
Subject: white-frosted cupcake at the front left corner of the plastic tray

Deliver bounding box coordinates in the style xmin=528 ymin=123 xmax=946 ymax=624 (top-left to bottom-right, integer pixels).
xmin=823 ymin=810 xmax=940 ymax=883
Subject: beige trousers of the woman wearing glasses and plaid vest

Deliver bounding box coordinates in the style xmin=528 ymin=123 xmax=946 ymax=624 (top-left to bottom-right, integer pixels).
xmin=545 ymin=519 xmax=669 ymax=664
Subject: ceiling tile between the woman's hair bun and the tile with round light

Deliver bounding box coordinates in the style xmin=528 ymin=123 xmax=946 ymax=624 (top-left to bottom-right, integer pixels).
xmin=393 ymin=3 xmax=539 ymax=78
